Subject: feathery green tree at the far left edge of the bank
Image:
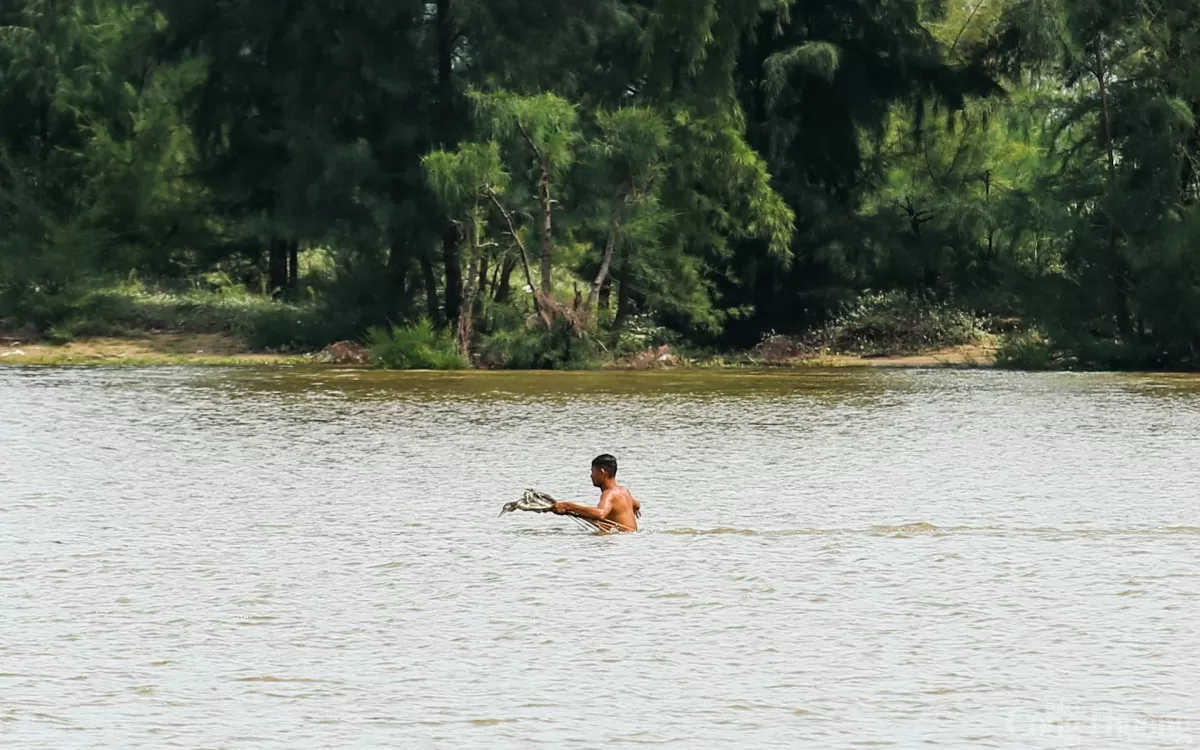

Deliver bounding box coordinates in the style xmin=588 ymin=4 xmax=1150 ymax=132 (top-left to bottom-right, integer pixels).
xmin=0 ymin=0 xmax=204 ymax=325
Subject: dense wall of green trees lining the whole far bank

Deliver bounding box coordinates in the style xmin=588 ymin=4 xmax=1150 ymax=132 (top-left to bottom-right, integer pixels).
xmin=0 ymin=0 xmax=1200 ymax=366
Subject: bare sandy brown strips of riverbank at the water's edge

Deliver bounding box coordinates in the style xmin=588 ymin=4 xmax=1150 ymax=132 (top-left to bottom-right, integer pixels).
xmin=0 ymin=332 xmax=996 ymax=370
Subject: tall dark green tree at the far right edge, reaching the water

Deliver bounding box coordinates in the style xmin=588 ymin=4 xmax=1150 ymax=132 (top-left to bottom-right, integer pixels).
xmin=986 ymin=0 xmax=1200 ymax=366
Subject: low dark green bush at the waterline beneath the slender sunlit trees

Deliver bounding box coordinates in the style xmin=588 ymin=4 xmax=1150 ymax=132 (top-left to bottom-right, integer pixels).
xmin=479 ymin=318 xmax=599 ymax=370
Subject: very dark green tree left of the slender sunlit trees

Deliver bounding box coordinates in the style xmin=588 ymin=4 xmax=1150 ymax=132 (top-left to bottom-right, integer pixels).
xmin=158 ymin=0 xmax=437 ymax=322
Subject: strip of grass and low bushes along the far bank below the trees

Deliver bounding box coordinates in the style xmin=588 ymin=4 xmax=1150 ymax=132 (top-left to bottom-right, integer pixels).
xmin=0 ymin=282 xmax=1008 ymax=370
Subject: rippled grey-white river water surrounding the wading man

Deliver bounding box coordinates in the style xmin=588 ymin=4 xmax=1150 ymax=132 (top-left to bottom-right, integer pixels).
xmin=0 ymin=368 xmax=1200 ymax=750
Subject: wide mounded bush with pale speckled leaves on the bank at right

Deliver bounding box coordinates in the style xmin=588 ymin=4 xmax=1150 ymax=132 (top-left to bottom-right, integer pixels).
xmin=811 ymin=292 xmax=984 ymax=355
